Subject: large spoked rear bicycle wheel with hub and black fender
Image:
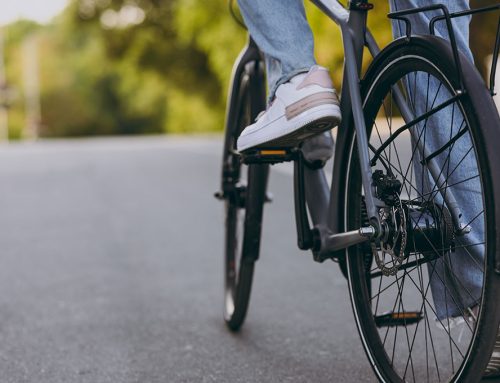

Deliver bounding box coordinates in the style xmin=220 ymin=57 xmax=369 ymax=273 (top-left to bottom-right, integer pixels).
xmin=344 ymin=37 xmax=500 ymax=382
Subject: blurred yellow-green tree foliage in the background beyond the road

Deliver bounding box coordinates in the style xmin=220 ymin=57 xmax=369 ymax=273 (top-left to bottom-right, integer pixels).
xmin=1 ymin=0 xmax=498 ymax=138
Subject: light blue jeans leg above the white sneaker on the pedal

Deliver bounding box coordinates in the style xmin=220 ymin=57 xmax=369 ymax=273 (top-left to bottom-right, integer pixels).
xmin=238 ymin=0 xmax=316 ymax=99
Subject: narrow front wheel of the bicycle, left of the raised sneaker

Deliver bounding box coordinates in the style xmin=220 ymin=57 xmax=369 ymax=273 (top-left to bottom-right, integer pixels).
xmin=223 ymin=61 xmax=269 ymax=331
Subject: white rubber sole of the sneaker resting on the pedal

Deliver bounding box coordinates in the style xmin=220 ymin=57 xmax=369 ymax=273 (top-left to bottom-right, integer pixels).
xmin=238 ymin=105 xmax=341 ymax=152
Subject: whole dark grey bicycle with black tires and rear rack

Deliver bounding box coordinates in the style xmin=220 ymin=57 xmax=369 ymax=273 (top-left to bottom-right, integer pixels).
xmin=216 ymin=0 xmax=500 ymax=382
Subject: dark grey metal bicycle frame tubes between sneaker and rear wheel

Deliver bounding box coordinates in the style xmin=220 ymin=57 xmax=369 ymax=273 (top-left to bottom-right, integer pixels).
xmin=305 ymin=0 xmax=382 ymax=262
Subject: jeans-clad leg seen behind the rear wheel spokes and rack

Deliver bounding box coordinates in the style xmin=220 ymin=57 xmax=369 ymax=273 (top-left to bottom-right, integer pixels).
xmin=391 ymin=0 xmax=484 ymax=323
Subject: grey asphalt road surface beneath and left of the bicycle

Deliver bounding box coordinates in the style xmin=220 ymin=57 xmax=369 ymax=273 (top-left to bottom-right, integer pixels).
xmin=0 ymin=137 xmax=496 ymax=383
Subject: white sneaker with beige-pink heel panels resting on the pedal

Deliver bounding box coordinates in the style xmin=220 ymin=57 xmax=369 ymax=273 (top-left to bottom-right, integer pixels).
xmin=237 ymin=65 xmax=341 ymax=151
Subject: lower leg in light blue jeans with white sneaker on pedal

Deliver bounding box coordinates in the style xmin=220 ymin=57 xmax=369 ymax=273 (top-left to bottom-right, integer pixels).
xmin=237 ymin=0 xmax=340 ymax=154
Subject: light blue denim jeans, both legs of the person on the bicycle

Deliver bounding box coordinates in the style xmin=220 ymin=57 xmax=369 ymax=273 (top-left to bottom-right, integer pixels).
xmin=238 ymin=0 xmax=484 ymax=319
